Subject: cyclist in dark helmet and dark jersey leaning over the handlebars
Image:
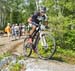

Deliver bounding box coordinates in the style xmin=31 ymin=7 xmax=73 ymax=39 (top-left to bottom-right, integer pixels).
xmin=28 ymin=9 xmax=48 ymax=41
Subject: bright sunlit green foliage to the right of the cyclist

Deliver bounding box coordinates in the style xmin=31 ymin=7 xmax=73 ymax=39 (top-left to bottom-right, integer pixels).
xmin=44 ymin=0 xmax=75 ymax=50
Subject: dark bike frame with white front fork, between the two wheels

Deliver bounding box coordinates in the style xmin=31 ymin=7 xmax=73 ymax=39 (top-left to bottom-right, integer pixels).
xmin=32 ymin=25 xmax=48 ymax=48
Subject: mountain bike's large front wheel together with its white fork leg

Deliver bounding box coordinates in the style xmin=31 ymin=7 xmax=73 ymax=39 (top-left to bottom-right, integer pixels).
xmin=37 ymin=33 xmax=56 ymax=59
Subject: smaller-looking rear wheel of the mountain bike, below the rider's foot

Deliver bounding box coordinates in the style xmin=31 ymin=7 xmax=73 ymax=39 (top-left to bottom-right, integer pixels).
xmin=23 ymin=37 xmax=32 ymax=57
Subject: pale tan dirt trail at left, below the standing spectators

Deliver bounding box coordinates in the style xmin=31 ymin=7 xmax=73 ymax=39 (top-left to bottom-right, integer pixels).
xmin=0 ymin=37 xmax=24 ymax=55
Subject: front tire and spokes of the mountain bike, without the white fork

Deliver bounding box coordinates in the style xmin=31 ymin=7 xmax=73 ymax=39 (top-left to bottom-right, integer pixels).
xmin=37 ymin=32 xmax=56 ymax=59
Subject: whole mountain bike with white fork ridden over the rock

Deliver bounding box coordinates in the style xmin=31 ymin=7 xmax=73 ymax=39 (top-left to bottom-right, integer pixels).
xmin=23 ymin=24 xmax=56 ymax=59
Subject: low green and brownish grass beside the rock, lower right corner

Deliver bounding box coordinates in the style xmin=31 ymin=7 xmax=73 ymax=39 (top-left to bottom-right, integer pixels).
xmin=53 ymin=48 xmax=75 ymax=64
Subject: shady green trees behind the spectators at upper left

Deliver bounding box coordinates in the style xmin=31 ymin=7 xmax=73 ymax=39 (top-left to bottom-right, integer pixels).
xmin=0 ymin=0 xmax=35 ymax=25
